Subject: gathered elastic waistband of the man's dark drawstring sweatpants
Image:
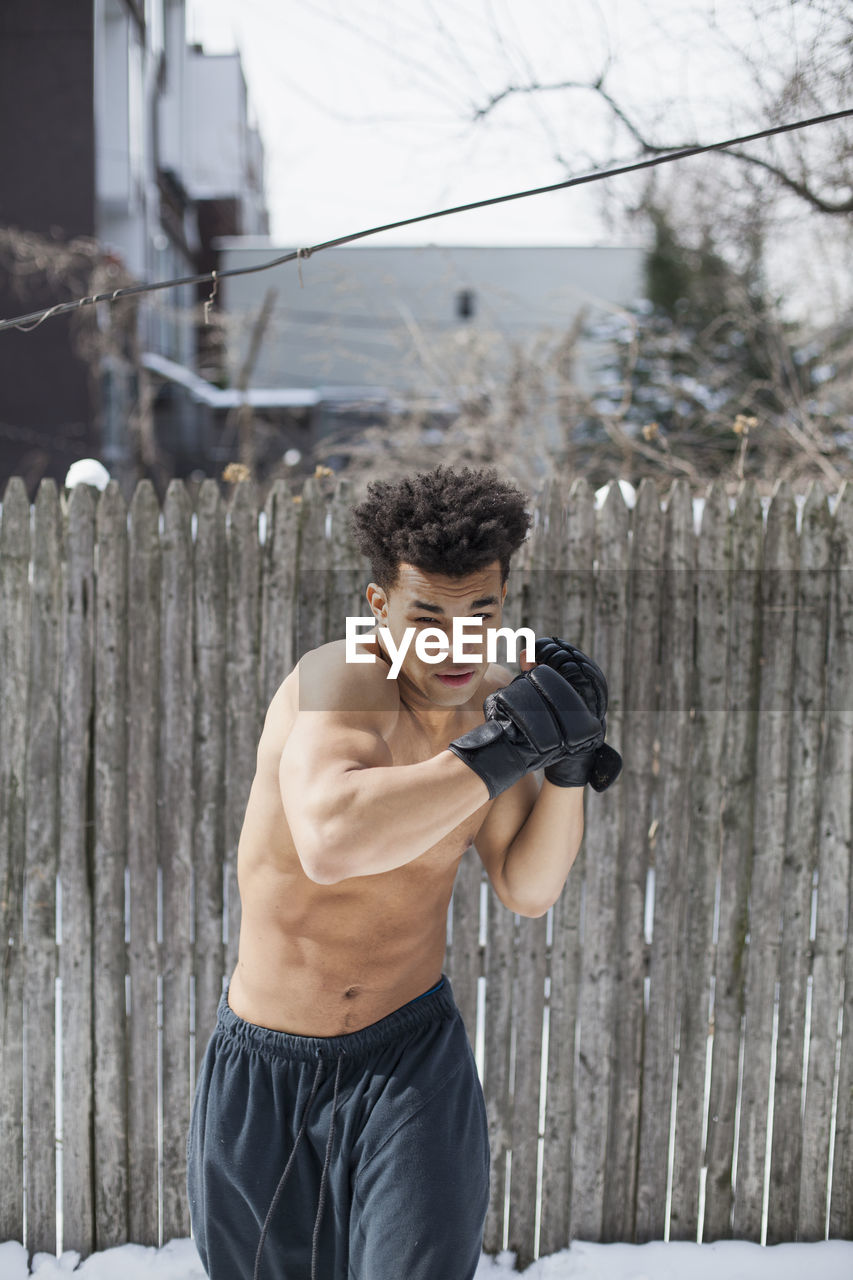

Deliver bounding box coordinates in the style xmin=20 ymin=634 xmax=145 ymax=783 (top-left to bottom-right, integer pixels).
xmin=216 ymin=974 xmax=457 ymax=1061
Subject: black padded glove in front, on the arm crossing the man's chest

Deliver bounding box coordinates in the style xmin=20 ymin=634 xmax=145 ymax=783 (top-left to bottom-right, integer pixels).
xmin=448 ymin=666 xmax=605 ymax=799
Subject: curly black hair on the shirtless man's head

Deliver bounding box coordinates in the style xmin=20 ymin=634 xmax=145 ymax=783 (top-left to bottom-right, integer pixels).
xmin=350 ymin=463 xmax=533 ymax=591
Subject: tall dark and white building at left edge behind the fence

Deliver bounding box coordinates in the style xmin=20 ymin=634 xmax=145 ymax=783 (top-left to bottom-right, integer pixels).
xmin=0 ymin=0 xmax=268 ymax=494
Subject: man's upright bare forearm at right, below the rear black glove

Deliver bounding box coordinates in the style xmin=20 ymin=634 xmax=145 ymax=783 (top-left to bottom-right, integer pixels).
xmin=501 ymin=780 xmax=584 ymax=915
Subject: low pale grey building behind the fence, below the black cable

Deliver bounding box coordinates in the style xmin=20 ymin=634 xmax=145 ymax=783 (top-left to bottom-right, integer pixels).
xmin=192 ymin=239 xmax=644 ymax=476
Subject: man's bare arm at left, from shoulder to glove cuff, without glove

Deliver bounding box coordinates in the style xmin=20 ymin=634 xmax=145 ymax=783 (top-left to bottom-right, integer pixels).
xmin=279 ymin=666 xmax=489 ymax=884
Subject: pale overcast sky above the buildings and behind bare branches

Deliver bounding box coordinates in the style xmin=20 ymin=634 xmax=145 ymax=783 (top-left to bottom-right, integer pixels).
xmin=188 ymin=0 xmax=853 ymax=317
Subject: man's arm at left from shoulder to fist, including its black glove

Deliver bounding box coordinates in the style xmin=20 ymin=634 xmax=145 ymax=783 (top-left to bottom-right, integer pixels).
xmin=279 ymin=645 xmax=605 ymax=884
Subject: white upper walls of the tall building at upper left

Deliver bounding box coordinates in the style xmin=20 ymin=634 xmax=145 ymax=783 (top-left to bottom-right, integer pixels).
xmin=95 ymin=0 xmax=268 ymax=278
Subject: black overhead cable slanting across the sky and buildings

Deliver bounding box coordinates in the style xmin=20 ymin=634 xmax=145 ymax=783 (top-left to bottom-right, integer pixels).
xmin=0 ymin=108 xmax=853 ymax=333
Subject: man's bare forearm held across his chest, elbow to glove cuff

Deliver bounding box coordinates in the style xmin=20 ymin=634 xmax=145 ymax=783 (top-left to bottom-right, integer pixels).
xmin=295 ymin=751 xmax=489 ymax=883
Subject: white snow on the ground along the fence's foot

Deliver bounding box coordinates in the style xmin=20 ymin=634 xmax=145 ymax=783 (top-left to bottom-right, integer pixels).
xmin=0 ymin=1239 xmax=853 ymax=1280
